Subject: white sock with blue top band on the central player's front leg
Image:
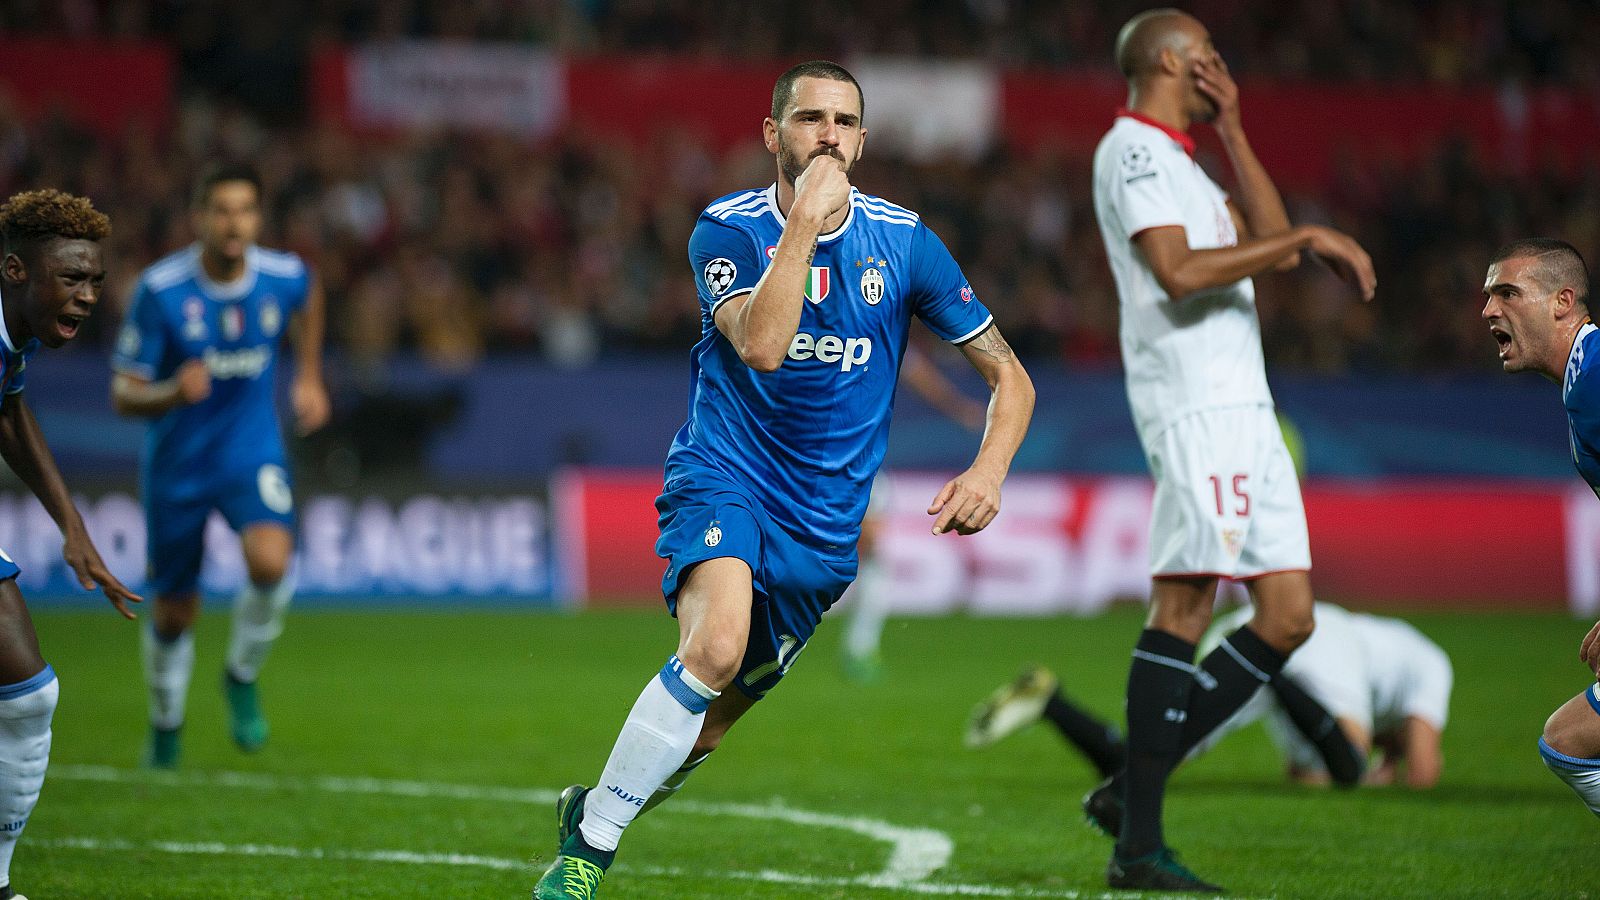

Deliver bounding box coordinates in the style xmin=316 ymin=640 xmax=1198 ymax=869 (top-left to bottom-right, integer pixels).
xmin=579 ymin=657 xmax=717 ymax=850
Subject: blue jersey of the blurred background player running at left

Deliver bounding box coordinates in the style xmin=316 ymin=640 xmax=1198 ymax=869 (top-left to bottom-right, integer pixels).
xmin=112 ymin=245 xmax=310 ymax=495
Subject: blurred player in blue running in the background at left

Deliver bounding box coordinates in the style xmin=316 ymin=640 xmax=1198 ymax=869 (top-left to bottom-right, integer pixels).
xmin=112 ymin=165 xmax=328 ymax=769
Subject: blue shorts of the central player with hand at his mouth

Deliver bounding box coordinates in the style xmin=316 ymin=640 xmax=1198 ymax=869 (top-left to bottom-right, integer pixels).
xmin=656 ymin=468 xmax=856 ymax=700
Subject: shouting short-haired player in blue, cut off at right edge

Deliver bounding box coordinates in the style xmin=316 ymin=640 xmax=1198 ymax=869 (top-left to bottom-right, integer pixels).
xmin=1483 ymin=237 xmax=1600 ymax=815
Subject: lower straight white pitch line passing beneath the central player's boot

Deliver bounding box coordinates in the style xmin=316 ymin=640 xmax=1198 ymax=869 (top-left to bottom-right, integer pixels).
xmin=40 ymin=838 xmax=1149 ymax=900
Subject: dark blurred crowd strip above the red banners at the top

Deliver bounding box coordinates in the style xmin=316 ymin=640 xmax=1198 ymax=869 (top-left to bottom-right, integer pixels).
xmin=0 ymin=0 xmax=1600 ymax=91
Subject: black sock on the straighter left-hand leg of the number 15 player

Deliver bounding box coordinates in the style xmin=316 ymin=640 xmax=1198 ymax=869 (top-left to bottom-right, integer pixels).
xmin=1117 ymin=628 xmax=1195 ymax=860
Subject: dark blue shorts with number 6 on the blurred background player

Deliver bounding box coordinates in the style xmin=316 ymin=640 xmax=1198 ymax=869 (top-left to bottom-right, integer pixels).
xmin=144 ymin=463 xmax=294 ymax=596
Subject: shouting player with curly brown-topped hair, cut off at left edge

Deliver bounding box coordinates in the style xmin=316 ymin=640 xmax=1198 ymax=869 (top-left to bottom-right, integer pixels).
xmin=0 ymin=191 xmax=141 ymax=900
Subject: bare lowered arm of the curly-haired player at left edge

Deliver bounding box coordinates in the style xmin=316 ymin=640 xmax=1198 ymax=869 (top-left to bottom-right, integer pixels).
xmin=0 ymin=392 xmax=142 ymax=618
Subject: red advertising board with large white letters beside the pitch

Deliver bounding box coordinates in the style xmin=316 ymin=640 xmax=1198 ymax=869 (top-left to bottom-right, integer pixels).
xmin=552 ymin=471 xmax=1580 ymax=615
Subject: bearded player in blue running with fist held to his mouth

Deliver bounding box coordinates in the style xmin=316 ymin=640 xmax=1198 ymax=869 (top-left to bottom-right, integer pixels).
xmin=534 ymin=61 xmax=1034 ymax=898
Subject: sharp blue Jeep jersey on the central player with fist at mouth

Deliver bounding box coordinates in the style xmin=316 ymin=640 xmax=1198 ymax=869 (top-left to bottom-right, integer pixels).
xmin=667 ymin=184 xmax=994 ymax=556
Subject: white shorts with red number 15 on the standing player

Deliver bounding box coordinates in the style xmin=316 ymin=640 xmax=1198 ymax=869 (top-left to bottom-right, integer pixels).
xmin=1144 ymin=405 xmax=1310 ymax=578
